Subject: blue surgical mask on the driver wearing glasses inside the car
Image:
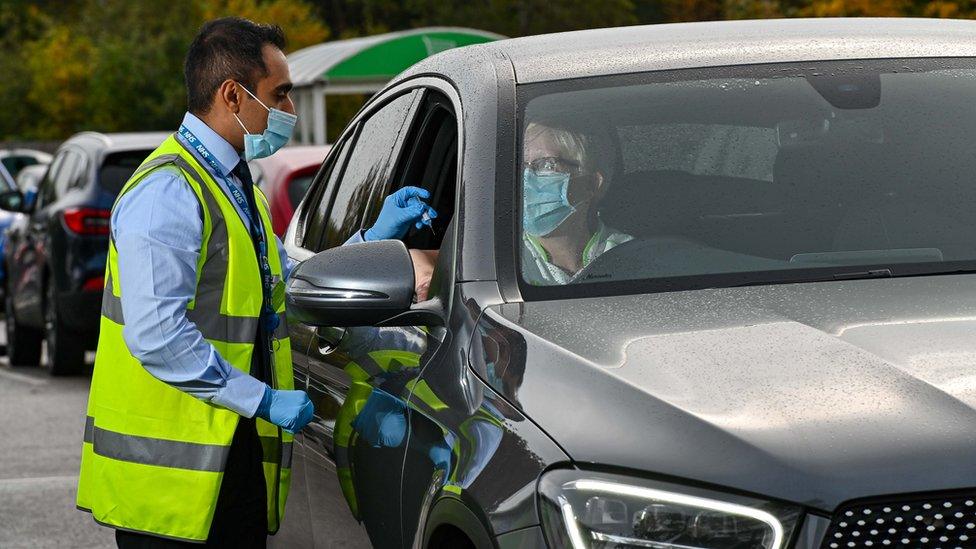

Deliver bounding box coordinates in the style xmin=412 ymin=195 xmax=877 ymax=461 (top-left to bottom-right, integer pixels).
xmin=522 ymin=168 xmax=576 ymax=236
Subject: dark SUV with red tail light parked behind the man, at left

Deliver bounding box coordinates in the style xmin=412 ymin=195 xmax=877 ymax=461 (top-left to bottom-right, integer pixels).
xmin=2 ymin=132 xmax=167 ymax=375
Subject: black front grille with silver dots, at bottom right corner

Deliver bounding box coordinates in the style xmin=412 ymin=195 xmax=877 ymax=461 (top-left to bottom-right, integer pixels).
xmin=821 ymin=493 xmax=976 ymax=549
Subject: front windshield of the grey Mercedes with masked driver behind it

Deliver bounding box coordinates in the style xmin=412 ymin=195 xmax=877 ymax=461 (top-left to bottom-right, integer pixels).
xmin=518 ymin=59 xmax=976 ymax=298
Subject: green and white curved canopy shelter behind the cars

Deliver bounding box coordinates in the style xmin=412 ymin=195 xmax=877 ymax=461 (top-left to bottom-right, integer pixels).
xmin=288 ymin=27 xmax=504 ymax=144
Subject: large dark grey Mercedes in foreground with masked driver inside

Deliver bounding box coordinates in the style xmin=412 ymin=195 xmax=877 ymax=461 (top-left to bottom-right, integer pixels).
xmin=281 ymin=19 xmax=976 ymax=549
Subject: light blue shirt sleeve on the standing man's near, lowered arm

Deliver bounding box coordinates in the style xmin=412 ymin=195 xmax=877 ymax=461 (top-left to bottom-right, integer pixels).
xmin=111 ymin=168 xmax=266 ymax=417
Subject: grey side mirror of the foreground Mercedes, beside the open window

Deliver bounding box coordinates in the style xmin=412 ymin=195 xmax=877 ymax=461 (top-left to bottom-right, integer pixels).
xmin=286 ymin=240 xmax=442 ymax=326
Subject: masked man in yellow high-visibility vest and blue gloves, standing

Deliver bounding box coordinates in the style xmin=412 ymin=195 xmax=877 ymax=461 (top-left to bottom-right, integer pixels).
xmin=77 ymin=18 xmax=436 ymax=547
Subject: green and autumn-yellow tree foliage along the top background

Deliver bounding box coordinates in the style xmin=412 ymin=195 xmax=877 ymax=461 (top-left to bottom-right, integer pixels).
xmin=0 ymin=0 xmax=976 ymax=141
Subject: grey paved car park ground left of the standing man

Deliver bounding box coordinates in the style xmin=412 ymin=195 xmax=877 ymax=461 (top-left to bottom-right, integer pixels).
xmin=0 ymin=344 xmax=115 ymax=549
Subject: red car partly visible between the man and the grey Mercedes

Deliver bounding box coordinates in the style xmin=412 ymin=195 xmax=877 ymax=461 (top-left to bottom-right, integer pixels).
xmin=250 ymin=145 xmax=329 ymax=236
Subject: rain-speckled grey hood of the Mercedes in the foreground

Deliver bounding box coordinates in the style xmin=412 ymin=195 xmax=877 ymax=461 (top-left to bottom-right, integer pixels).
xmin=486 ymin=275 xmax=976 ymax=510
